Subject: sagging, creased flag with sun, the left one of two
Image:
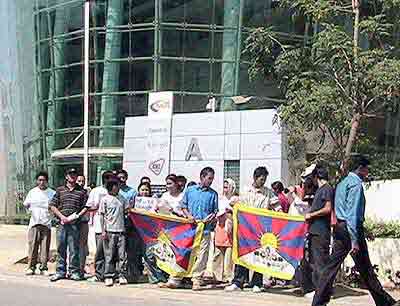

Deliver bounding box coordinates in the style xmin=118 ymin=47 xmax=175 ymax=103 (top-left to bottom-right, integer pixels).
xmin=129 ymin=209 xmax=204 ymax=277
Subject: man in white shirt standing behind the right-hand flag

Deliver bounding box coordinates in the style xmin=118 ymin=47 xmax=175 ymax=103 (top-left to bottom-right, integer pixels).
xmin=225 ymin=167 xmax=281 ymax=293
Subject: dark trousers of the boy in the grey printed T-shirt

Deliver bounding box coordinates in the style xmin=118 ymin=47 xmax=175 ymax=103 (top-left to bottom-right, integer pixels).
xmin=103 ymin=232 xmax=126 ymax=278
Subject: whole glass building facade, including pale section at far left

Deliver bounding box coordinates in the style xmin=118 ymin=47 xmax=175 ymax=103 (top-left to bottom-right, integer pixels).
xmin=0 ymin=0 xmax=400 ymax=212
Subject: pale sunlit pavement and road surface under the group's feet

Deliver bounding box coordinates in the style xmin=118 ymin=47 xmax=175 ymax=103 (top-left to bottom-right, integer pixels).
xmin=0 ymin=225 xmax=400 ymax=306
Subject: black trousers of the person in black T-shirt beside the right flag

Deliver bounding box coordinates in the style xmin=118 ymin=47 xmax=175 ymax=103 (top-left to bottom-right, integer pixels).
xmin=308 ymin=234 xmax=331 ymax=288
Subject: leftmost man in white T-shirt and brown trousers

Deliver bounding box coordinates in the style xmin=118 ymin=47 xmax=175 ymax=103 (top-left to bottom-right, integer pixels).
xmin=24 ymin=172 xmax=55 ymax=275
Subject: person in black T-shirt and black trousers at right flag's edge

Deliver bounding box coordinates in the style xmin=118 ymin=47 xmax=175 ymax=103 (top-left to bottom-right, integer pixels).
xmin=305 ymin=168 xmax=333 ymax=298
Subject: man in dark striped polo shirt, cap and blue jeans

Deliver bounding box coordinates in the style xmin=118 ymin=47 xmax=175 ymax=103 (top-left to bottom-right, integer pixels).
xmin=49 ymin=168 xmax=87 ymax=282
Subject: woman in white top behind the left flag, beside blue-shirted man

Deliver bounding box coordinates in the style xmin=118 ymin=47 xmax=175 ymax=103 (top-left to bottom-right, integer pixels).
xmin=157 ymin=174 xmax=184 ymax=217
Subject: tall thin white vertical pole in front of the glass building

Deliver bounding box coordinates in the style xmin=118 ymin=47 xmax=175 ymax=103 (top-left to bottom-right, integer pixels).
xmin=83 ymin=0 xmax=90 ymax=187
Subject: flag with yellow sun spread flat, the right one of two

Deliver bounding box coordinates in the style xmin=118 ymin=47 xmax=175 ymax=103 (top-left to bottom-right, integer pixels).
xmin=233 ymin=205 xmax=307 ymax=280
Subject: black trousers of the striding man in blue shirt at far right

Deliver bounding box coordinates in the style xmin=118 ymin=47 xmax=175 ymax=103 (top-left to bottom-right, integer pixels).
xmin=312 ymin=221 xmax=396 ymax=306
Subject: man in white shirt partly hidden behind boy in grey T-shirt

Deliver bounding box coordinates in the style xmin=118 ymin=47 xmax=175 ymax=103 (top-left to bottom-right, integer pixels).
xmin=87 ymin=171 xmax=115 ymax=282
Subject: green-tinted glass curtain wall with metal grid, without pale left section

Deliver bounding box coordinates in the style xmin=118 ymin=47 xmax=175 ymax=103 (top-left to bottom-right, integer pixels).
xmin=34 ymin=0 xmax=400 ymax=183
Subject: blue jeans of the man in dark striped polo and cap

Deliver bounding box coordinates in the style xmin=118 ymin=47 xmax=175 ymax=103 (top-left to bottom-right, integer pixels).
xmin=56 ymin=224 xmax=80 ymax=276
